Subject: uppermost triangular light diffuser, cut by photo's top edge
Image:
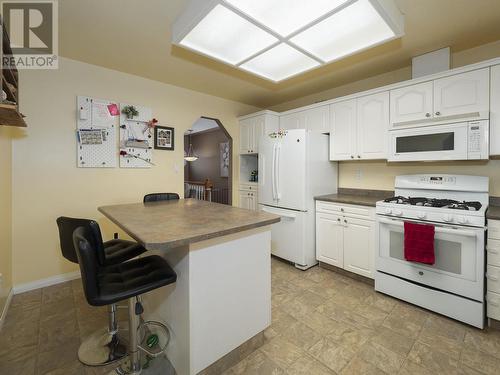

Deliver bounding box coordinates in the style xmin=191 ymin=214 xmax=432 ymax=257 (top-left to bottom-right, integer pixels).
xmin=224 ymin=0 xmax=348 ymax=36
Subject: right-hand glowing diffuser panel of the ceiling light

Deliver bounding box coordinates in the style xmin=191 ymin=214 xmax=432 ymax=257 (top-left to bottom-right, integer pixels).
xmin=291 ymin=0 xmax=396 ymax=61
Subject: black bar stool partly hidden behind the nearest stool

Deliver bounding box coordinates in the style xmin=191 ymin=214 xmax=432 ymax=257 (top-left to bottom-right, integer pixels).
xmin=56 ymin=216 xmax=146 ymax=366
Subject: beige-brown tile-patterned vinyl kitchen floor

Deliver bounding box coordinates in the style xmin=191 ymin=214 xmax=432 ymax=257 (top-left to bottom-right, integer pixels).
xmin=0 ymin=259 xmax=500 ymax=375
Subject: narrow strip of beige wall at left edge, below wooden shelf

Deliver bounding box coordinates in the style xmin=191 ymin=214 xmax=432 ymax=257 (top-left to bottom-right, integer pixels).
xmin=0 ymin=126 xmax=12 ymax=315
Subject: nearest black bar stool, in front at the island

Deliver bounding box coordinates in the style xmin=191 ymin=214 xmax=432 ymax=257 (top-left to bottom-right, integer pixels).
xmin=73 ymin=221 xmax=177 ymax=375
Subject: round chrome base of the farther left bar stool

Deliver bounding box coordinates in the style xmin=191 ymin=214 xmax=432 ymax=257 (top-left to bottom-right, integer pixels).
xmin=78 ymin=329 xmax=127 ymax=366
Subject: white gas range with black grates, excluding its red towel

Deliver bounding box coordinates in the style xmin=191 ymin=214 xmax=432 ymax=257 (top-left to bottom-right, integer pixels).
xmin=375 ymin=175 xmax=489 ymax=328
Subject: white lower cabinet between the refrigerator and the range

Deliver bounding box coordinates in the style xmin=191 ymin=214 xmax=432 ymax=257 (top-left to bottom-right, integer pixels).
xmin=316 ymin=202 xmax=375 ymax=279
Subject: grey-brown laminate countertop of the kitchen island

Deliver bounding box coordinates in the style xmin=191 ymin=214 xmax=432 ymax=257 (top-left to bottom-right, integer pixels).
xmin=99 ymin=199 xmax=280 ymax=250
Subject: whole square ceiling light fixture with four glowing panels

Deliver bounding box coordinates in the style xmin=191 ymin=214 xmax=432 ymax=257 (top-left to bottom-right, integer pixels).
xmin=172 ymin=0 xmax=404 ymax=82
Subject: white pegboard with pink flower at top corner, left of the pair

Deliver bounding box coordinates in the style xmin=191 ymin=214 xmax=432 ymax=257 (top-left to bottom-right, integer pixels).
xmin=76 ymin=96 xmax=119 ymax=168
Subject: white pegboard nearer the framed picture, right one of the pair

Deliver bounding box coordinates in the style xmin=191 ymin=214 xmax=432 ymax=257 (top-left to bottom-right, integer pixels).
xmin=119 ymin=103 xmax=154 ymax=168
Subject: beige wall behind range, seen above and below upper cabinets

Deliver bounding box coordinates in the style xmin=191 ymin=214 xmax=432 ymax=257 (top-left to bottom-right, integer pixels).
xmin=272 ymin=41 xmax=500 ymax=196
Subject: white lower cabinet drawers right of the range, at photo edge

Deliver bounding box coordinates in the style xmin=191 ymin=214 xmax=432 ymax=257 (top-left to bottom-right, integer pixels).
xmin=486 ymin=220 xmax=500 ymax=320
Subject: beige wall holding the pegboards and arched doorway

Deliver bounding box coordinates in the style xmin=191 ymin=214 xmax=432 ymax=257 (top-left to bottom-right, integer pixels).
xmin=13 ymin=58 xmax=257 ymax=285
